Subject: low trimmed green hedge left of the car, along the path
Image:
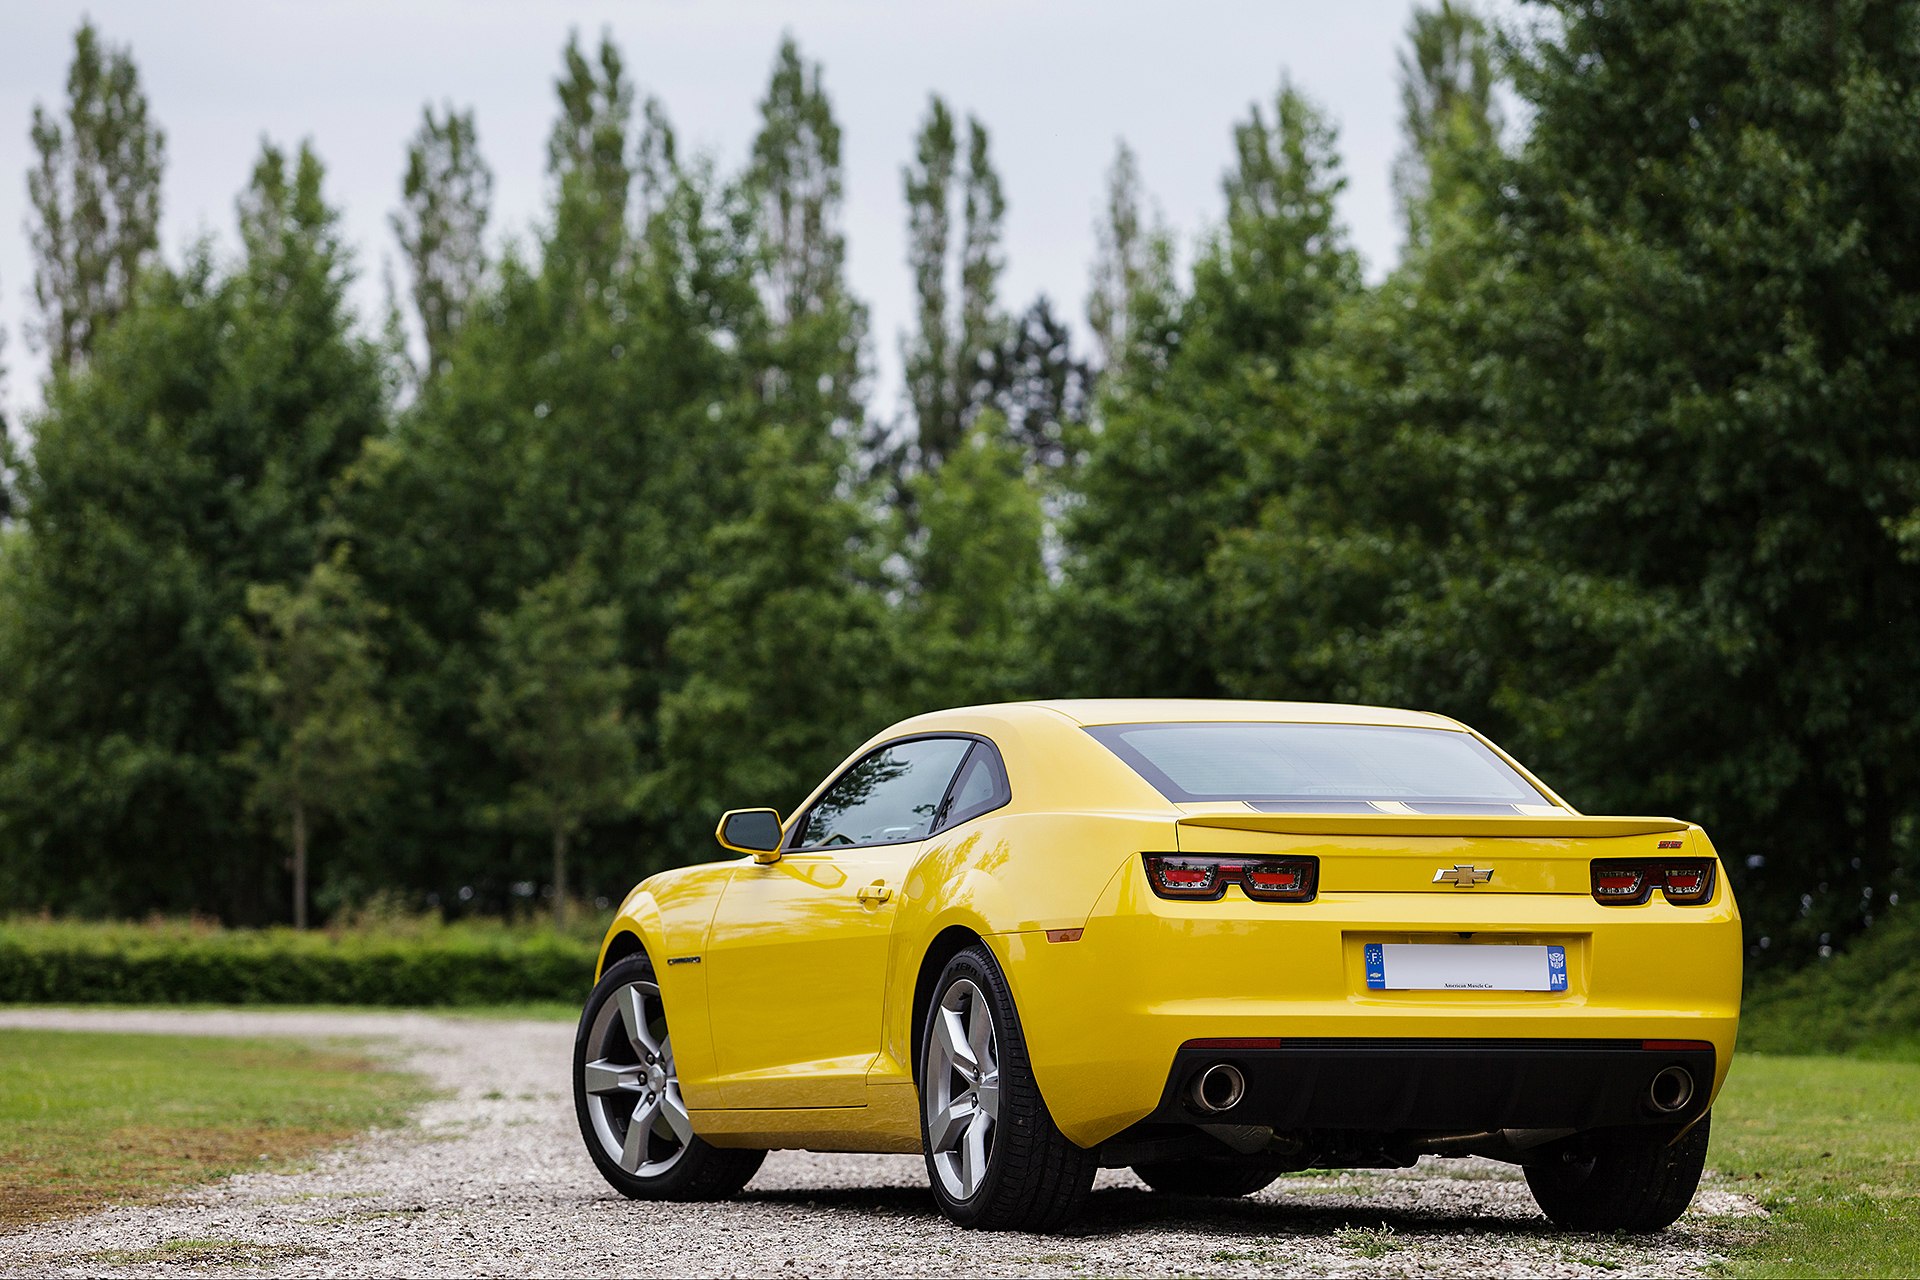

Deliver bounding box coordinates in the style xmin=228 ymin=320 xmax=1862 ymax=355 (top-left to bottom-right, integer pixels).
xmin=0 ymin=923 xmax=597 ymax=1006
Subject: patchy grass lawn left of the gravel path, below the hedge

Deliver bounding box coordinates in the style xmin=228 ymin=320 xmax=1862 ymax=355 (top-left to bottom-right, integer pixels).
xmin=0 ymin=1031 xmax=426 ymax=1232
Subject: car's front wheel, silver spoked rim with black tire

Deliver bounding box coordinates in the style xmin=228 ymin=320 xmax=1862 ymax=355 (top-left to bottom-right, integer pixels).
xmin=574 ymin=956 xmax=766 ymax=1199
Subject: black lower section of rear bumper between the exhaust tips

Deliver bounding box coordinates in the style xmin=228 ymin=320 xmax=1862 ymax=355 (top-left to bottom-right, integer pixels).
xmin=1146 ymin=1038 xmax=1715 ymax=1134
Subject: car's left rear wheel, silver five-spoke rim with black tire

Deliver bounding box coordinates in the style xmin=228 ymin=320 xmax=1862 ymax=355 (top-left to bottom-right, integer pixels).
xmin=920 ymin=946 xmax=1098 ymax=1232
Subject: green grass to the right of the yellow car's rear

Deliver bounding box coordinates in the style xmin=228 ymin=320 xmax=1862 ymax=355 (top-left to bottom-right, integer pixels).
xmin=1709 ymin=1044 xmax=1920 ymax=1276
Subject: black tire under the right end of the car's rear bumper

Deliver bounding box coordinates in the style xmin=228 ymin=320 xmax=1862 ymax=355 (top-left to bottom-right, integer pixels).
xmin=1526 ymin=1113 xmax=1713 ymax=1232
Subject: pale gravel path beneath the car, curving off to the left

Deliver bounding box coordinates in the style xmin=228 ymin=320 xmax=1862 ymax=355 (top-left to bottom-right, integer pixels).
xmin=0 ymin=1009 xmax=1761 ymax=1276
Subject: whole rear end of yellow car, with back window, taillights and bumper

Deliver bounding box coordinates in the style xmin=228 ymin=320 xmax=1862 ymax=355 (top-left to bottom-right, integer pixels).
xmin=1014 ymin=718 xmax=1741 ymax=1167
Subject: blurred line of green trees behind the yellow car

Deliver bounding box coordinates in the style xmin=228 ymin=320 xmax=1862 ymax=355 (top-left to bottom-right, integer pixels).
xmin=0 ymin=0 xmax=1920 ymax=956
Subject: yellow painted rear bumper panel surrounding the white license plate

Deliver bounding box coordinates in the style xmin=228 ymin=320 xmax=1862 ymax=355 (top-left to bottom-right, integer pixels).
xmin=989 ymin=873 xmax=1741 ymax=1148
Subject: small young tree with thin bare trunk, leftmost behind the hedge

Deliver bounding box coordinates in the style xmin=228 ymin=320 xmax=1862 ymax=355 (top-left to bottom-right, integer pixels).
xmin=232 ymin=547 xmax=409 ymax=929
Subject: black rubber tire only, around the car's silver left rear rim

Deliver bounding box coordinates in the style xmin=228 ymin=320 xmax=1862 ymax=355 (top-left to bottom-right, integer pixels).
xmin=920 ymin=946 xmax=1100 ymax=1232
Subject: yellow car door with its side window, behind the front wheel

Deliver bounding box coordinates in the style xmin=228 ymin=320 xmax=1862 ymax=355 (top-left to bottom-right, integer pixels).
xmin=705 ymin=737 xmax=973 ymax=1109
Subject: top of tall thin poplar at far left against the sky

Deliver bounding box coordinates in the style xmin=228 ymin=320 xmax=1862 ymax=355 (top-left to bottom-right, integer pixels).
xmin=27 ymin=21 xmax=167 ymax=372
